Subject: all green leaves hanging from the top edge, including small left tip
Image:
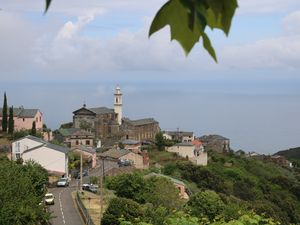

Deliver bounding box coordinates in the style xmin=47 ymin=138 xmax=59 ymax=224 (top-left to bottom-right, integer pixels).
xmin=45 ymin=0 xmax=238 ymax=62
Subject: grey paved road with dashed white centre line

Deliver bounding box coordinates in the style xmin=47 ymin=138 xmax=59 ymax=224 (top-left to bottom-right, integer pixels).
xmin=49 ymin=181 xmax=84 ymax=225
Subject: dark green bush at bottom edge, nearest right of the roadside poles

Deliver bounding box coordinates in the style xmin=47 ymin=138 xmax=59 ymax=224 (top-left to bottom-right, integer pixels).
xmin=101 ymin=198 xmax=143 ymax=225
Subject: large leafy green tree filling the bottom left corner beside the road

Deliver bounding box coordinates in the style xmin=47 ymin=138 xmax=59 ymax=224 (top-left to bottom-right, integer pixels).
xmin=0 ymin=160 xmax=50 ymax=225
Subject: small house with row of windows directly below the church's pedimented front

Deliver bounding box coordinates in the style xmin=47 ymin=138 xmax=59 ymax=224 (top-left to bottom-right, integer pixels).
xmin=55 ymin=128 xmax=95 ymax=148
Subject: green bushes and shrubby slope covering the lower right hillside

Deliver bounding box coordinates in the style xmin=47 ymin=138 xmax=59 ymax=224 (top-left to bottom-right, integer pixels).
xmin=103 ymin=150 xmax=300 ymax=225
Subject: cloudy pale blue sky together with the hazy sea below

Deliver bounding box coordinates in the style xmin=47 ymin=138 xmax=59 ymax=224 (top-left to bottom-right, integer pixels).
xmin=0 ymin=0 xmax=300 ymax=154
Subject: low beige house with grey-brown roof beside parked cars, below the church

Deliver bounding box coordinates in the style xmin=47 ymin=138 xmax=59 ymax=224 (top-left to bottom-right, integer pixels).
xmin=100 ymin=149 xmax=149 ymax=169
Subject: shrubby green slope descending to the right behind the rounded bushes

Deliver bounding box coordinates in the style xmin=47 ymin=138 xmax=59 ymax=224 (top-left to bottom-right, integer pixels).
xmin=149 ymin=151 xmax=300 ymax=224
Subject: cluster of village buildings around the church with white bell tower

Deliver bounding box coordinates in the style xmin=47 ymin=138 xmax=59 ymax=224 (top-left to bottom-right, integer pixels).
xmin=0 ymin=87 xmax=230 ymax=176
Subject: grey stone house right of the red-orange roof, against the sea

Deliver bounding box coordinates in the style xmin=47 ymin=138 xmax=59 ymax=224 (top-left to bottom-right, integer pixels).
xmin=198 ymin=134 xmax=230 ymax=153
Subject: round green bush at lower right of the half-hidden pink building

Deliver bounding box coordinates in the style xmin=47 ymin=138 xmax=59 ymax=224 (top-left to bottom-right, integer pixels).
xmin=187 ymin=190 xmax=225 ymax=221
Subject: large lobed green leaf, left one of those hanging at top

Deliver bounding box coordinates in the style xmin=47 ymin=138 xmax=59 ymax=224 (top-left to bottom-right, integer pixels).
xmin=149 ymin=0 xmax=201 ymax=54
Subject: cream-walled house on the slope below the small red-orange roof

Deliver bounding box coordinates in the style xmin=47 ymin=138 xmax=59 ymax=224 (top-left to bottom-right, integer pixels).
xmin=166 ymin=142 xmax=207 ymax=166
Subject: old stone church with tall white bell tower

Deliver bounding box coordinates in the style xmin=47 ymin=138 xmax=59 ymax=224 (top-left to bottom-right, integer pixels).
xmin=73 ymin=87 xmax=160 ymax=141
